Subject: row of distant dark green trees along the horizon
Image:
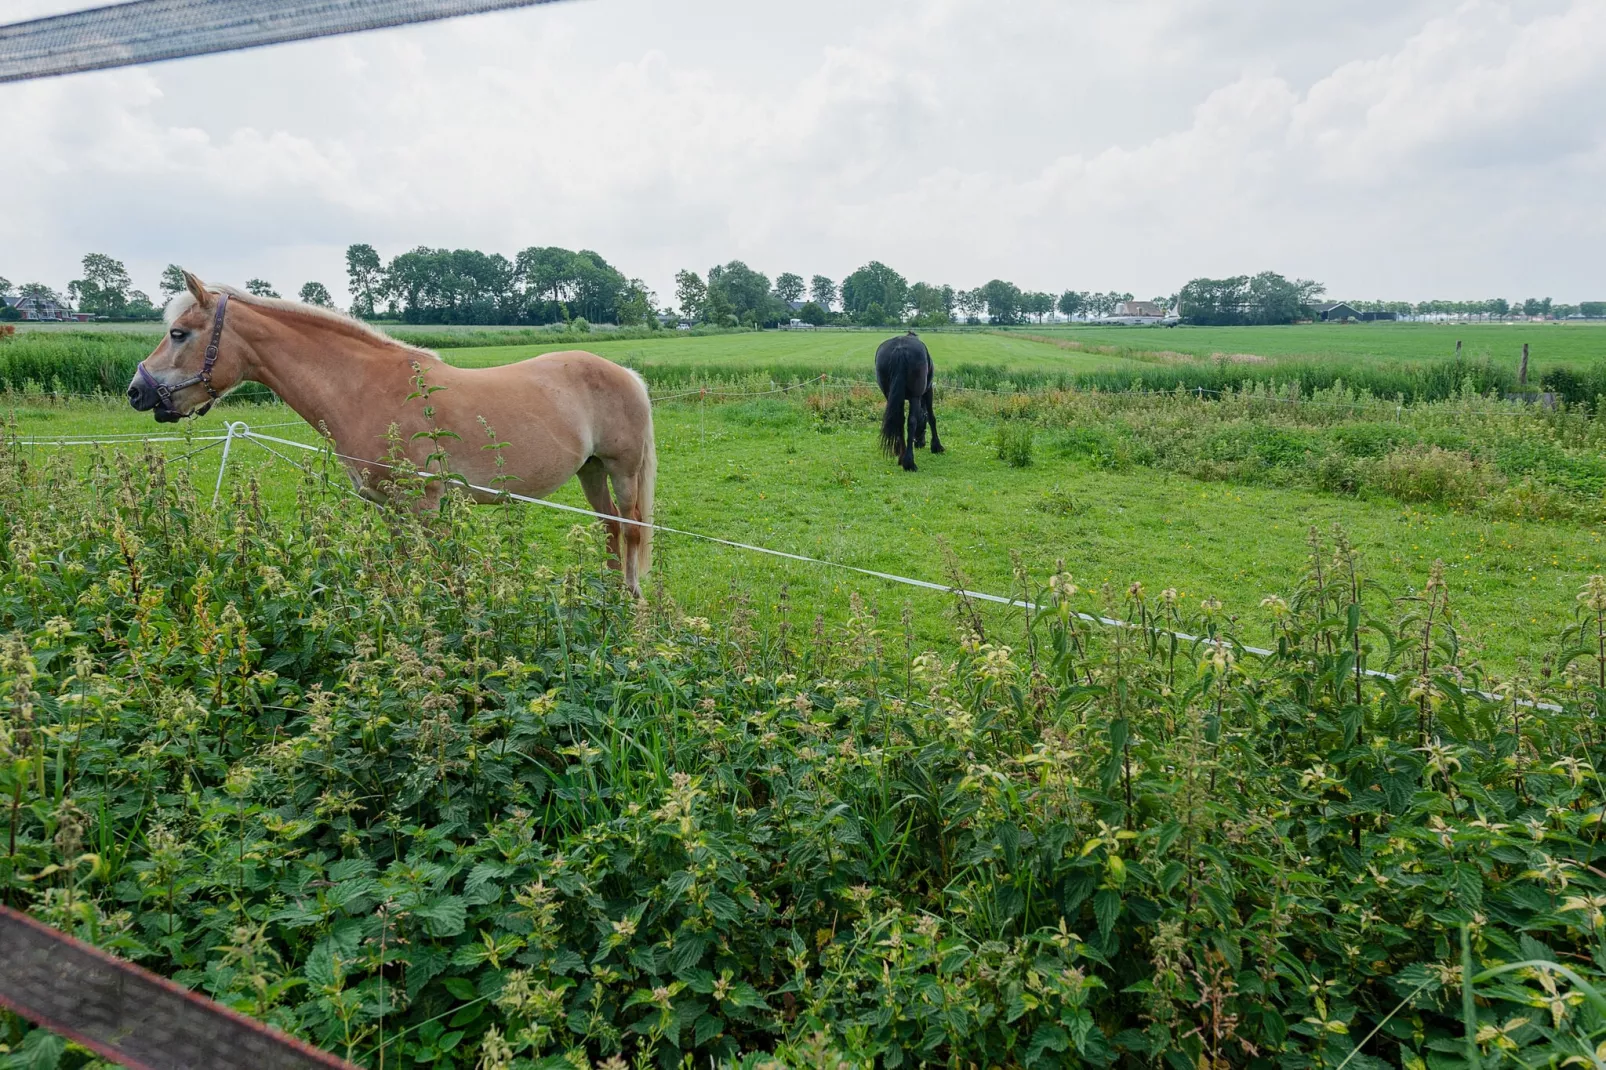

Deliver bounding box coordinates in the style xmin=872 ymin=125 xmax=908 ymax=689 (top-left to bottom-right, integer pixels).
xmin=0 ymin=244 xmax=1606 ymax=328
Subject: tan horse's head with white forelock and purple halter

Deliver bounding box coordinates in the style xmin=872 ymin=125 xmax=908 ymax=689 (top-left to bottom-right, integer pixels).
xmin=128 ymin=272 xmax=246 ymax=424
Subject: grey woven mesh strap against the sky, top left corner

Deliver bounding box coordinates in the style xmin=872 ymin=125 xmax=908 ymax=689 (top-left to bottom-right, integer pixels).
xmin=0 ymin=0 xmax=574 ymax=82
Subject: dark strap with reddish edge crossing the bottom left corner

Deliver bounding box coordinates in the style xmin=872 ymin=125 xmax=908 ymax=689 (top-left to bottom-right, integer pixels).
xmin=0 ymin=908 xmax=352 ymax=1070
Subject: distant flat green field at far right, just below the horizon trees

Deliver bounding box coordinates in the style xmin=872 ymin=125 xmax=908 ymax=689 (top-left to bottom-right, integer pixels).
xmin=1010 ymin=323 xmax=1606 ymax=368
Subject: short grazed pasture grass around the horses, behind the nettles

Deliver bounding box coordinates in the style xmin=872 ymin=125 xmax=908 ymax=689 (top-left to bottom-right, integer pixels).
xmin=16 ymin=397 xmax=1606 ymax=672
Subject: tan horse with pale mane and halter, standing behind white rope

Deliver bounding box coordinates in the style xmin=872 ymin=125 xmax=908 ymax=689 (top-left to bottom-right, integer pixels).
xmin=128 ymin=272 xmax=657 ymax=598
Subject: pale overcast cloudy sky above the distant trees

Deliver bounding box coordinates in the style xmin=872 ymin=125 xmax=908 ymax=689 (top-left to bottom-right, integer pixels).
xmin=0 ymin=0 xmax=1606 ymax=300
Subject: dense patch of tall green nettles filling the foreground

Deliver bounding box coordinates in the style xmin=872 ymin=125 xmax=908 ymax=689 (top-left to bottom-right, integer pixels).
xmin=0 ymin=427 xmax=1606 ymax=1070
